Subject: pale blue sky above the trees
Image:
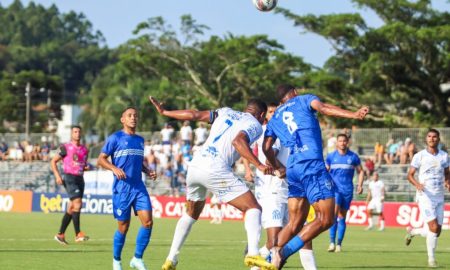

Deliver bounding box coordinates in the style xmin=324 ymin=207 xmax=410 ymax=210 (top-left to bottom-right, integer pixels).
xmin=0 ymin=0 xmax=450 ymax=66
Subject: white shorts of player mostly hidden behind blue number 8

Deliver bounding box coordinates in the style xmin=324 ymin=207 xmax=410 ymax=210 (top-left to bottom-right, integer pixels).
xmin=258 ymin=196 xmax=289 ymax=229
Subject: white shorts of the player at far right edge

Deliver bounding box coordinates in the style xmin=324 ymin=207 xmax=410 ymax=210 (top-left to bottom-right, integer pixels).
xmin=417 ymin=192 xmax=444 ymax=225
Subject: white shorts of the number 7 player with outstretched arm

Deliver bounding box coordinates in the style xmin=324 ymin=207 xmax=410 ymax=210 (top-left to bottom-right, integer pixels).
xmin=186 ymin=160 xmax=249 ymax=203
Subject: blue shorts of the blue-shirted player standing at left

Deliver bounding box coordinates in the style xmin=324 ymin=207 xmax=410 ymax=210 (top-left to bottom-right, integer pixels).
xmin=113 ymin=191 xmax=152 ymax=221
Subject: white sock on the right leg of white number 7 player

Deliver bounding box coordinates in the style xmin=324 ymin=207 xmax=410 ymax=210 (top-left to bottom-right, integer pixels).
xmin=245 ymin=208 xmax=261 ymax=256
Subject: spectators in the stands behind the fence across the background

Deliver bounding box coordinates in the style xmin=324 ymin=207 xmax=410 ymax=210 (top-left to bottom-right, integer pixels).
xmin=0 ymin=128 xmax=450 ymax=201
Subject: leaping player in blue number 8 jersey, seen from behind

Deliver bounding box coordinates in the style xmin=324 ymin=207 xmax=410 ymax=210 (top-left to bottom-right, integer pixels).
xmin=263 ymin=85 xmax=369 ymax=269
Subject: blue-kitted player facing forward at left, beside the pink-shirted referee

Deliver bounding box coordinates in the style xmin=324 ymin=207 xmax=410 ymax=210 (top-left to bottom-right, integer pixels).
xmin=98 ymin=107 xmax=156 ymax=270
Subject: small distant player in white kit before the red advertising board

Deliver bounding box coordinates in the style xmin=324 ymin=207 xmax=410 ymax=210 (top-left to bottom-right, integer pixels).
xmin=366 ymin=172 xmax=385 ymax=231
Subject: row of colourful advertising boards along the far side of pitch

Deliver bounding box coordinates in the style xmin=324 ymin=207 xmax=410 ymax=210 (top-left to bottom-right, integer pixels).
xmin=0 ymin=190 xmax=450 ymax=230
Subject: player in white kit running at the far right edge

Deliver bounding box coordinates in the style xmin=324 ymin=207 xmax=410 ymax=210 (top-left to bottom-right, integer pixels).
xmin=405 ymin=129 xmax=450 ymax=267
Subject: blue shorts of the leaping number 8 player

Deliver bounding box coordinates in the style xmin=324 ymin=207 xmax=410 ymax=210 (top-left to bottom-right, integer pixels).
xmin=287 ymin=160 xmax=335 ymax=204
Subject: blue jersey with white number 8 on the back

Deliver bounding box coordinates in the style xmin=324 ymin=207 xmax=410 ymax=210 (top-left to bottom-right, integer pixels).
xmin=265 ymin=94 xmax=323 ymax=167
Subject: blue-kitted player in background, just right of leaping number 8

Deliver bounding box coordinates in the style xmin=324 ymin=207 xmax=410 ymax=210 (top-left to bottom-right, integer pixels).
xmin=326 ymin=133 xmax=364 ymax=252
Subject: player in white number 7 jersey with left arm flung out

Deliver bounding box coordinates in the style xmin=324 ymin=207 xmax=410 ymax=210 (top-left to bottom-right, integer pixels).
xmin=150 ymin=97 xmax=275 ymax=270
